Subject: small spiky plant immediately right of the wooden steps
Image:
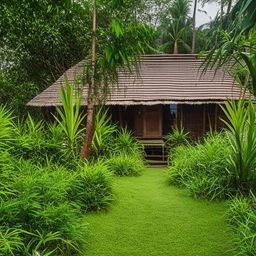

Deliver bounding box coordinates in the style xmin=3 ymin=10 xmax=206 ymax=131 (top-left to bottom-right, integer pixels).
xmin=164 ymin=127 xmax=189 ymax=150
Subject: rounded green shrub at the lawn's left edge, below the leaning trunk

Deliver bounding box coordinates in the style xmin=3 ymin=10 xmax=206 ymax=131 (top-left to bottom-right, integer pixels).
xmin=68 ymin=162 xmax=113 ymax=212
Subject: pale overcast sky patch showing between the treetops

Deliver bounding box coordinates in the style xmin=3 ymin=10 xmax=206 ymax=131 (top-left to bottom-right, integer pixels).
xmin=195 ymin=3 xmax=219 ymax=27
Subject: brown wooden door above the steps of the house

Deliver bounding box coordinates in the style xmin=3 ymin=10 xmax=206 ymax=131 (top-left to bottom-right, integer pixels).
xmin=143 ymin=105 xmax=163 ymax=138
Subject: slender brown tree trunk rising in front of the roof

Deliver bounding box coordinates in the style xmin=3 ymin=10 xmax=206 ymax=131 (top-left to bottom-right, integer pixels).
xmin=80 ymin=0 xmax=97 ymax=159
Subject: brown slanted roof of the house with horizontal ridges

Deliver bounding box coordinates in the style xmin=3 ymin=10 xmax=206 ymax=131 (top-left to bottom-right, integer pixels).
xmin=28 ymin=54 xmax=249 ymax=106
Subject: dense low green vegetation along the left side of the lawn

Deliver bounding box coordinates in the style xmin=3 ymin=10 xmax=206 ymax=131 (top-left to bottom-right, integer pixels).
xmin=0 ymin=104 xmax=143 ymax=256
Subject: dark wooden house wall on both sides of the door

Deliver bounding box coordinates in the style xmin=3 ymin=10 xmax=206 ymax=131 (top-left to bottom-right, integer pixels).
xmin=110 ymin=104 xmax=225 ymax=138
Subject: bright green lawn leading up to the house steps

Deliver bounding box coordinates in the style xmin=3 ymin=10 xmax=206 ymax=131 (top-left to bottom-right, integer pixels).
xmin=86 ymin=169 xmax=233 ymax=256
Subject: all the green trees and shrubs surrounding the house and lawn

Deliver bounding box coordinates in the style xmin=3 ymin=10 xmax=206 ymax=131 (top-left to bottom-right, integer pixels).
xmin=0 ymin=0 xmax=256 ymax=256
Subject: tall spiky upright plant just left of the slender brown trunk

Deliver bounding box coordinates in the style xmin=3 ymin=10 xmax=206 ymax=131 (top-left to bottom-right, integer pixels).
xmin=55 ymin=79 xmax=85 ymax=155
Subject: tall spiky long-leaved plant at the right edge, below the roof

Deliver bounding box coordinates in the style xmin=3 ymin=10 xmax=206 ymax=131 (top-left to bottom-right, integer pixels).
xmin=222 ymin=100 xmax=256 ymax=191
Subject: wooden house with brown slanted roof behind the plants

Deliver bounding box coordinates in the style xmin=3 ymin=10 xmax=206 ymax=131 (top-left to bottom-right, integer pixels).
xmin=28 ymin=54 xmax=249 ymax=140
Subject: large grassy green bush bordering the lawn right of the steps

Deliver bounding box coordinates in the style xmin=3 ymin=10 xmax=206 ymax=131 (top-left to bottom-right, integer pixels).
xmin=167 ymin=133 xmax=232 ymax=200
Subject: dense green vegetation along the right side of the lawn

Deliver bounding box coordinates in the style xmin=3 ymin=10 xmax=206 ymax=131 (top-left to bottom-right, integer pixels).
xmin=168 ymin=100 xmax=256 ymax=256
